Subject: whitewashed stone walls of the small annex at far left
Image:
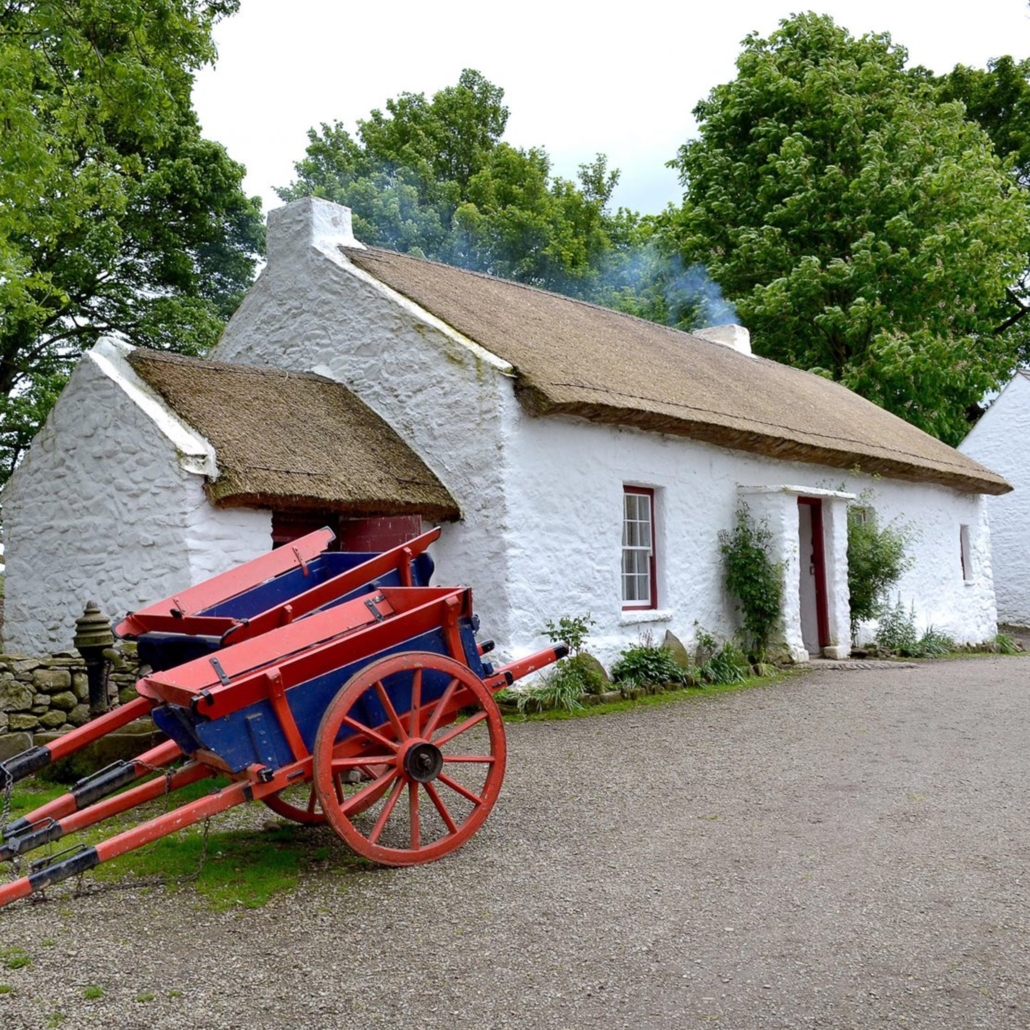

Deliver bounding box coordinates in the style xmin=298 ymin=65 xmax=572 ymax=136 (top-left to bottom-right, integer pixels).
xmin=3 ymin=341 xmax=271 ymax=654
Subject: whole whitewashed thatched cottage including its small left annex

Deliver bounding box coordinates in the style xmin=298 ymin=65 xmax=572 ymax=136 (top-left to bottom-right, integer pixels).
xmin=4 ymin=199 xmax=1009 ymax=659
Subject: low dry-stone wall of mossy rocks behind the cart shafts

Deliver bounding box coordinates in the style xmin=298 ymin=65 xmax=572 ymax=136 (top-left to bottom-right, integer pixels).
xmin=0 ymin=646 xmax=139 ymax=760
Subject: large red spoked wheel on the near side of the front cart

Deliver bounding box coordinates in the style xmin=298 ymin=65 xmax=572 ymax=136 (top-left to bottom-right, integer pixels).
xmin=313 ymin=651 xmax=507 ymax=865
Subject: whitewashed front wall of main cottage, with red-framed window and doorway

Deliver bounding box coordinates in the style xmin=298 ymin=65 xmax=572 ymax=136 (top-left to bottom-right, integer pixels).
xmin=508 ymin=415 xmax=997 ymax=661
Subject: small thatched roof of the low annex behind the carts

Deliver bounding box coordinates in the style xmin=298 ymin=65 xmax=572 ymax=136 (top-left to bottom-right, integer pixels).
xmin=129 ymin=349 xmax=460 ymax=521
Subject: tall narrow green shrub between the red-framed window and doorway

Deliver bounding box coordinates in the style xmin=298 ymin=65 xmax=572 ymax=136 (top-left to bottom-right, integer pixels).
xmin=719 ymin=504 xmax=783 ymax=661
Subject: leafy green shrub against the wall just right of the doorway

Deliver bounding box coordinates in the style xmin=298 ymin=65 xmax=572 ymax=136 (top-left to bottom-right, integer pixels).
xmin=848 ymin=493 xmax=912 ymax=640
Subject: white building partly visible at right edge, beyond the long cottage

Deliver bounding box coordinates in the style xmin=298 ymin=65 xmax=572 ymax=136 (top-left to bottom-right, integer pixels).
xmin=959 ymin=372 xmax=1030 ymax=626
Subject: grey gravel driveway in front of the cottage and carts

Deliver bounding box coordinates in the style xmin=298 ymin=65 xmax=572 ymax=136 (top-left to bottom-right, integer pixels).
xmin=0 ymin=657 xmax=1030 ymax=1030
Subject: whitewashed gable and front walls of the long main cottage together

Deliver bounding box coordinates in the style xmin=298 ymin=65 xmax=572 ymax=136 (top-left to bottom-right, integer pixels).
xmin=213 ymin=201 xmax=995 ymax=661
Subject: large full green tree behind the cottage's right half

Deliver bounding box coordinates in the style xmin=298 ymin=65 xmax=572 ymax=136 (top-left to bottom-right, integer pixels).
xmin=662 ymin=14 xmax=1030 ymax=443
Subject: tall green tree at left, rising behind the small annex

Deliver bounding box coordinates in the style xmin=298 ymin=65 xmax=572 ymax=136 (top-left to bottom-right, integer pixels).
xmin=0 ymin=0 xmax=264 ymax=482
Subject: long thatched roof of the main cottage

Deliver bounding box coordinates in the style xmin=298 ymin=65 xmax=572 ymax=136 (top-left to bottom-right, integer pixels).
xmin=344 ymin=248 xmax=1011 ymax=493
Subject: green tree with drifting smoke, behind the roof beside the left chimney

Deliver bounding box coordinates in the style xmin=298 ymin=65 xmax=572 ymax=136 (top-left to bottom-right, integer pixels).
xmin=276 ymin=68 xmax=618 ymax=296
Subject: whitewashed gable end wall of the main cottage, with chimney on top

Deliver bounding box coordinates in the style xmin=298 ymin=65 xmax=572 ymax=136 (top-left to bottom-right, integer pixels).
xmin=211 ymin=198 xmax=518 ymax=641
